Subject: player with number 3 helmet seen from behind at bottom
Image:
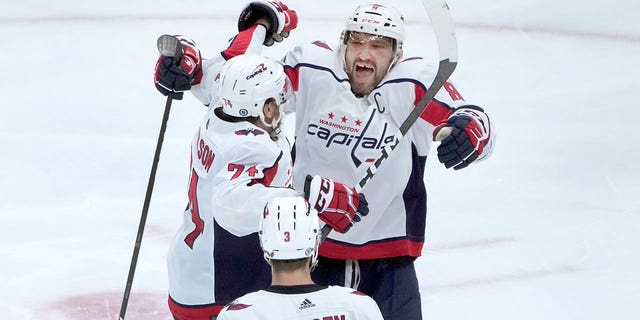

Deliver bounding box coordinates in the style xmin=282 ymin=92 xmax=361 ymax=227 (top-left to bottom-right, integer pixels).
xmin=218 ymin=197 xmax=382 ymax=320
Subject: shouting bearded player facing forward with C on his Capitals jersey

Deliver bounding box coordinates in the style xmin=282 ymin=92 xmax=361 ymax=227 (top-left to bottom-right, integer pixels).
xmin=154 ymin=1 xmax=495 ymax=319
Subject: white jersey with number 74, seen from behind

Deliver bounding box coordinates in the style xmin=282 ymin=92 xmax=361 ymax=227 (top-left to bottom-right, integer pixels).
xmin=168 ymin=100 xmax=300 ymax=308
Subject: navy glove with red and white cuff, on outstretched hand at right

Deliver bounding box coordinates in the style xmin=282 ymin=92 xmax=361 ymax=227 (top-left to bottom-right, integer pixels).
xmin=433 ymin=105 xmax=491 ymax=170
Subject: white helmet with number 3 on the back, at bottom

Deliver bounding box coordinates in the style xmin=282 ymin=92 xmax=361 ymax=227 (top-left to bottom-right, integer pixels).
xmin=259 ymin=196 xmax=320 ymax=266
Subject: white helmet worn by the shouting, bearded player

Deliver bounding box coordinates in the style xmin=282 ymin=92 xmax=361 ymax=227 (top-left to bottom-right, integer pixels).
xmin=342 ymin=4 xmax=405 ymax=53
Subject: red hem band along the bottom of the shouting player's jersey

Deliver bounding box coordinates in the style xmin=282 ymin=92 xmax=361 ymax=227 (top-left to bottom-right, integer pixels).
xmin=319 ymin=239 xmax=424 ymax=260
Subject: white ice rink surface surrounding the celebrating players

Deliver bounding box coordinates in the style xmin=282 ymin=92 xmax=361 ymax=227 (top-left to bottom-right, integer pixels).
xmin=0 ymin=0 xmax=640 ymax=320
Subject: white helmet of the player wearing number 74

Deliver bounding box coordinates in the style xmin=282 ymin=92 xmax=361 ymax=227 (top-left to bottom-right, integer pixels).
xmin=218 ymin=55 xmax=287 ymax=126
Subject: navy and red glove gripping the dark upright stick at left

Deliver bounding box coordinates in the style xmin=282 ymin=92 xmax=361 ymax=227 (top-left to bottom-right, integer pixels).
xmin=154 ymin=36 xmax=202 ymax=100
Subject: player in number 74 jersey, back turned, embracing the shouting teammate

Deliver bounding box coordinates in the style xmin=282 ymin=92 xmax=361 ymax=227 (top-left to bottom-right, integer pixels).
xmin=160 ymin=51 xmax=366 ymax=320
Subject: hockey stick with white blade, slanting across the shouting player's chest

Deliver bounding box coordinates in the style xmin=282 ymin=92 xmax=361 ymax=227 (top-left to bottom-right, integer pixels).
xmin=322 ymin=0 xmax=458 ymax=241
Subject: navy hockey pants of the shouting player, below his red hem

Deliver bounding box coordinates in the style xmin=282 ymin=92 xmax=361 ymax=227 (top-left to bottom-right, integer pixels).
xmin=312 ymin=257 xmax=422 ymax=320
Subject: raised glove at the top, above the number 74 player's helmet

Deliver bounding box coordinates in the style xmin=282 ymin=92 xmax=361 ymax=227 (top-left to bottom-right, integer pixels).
xmin=238 ymin=0 xmax=298 ymax=46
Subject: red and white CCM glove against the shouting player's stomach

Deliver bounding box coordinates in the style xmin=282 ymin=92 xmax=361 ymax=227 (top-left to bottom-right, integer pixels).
xmin=304 ymin=175 xmax=369 ymax=233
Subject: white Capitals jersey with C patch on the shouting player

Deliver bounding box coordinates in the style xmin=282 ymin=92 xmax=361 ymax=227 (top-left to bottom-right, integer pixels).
xmin=283 ymin=41 xmax=491 ymax=259
